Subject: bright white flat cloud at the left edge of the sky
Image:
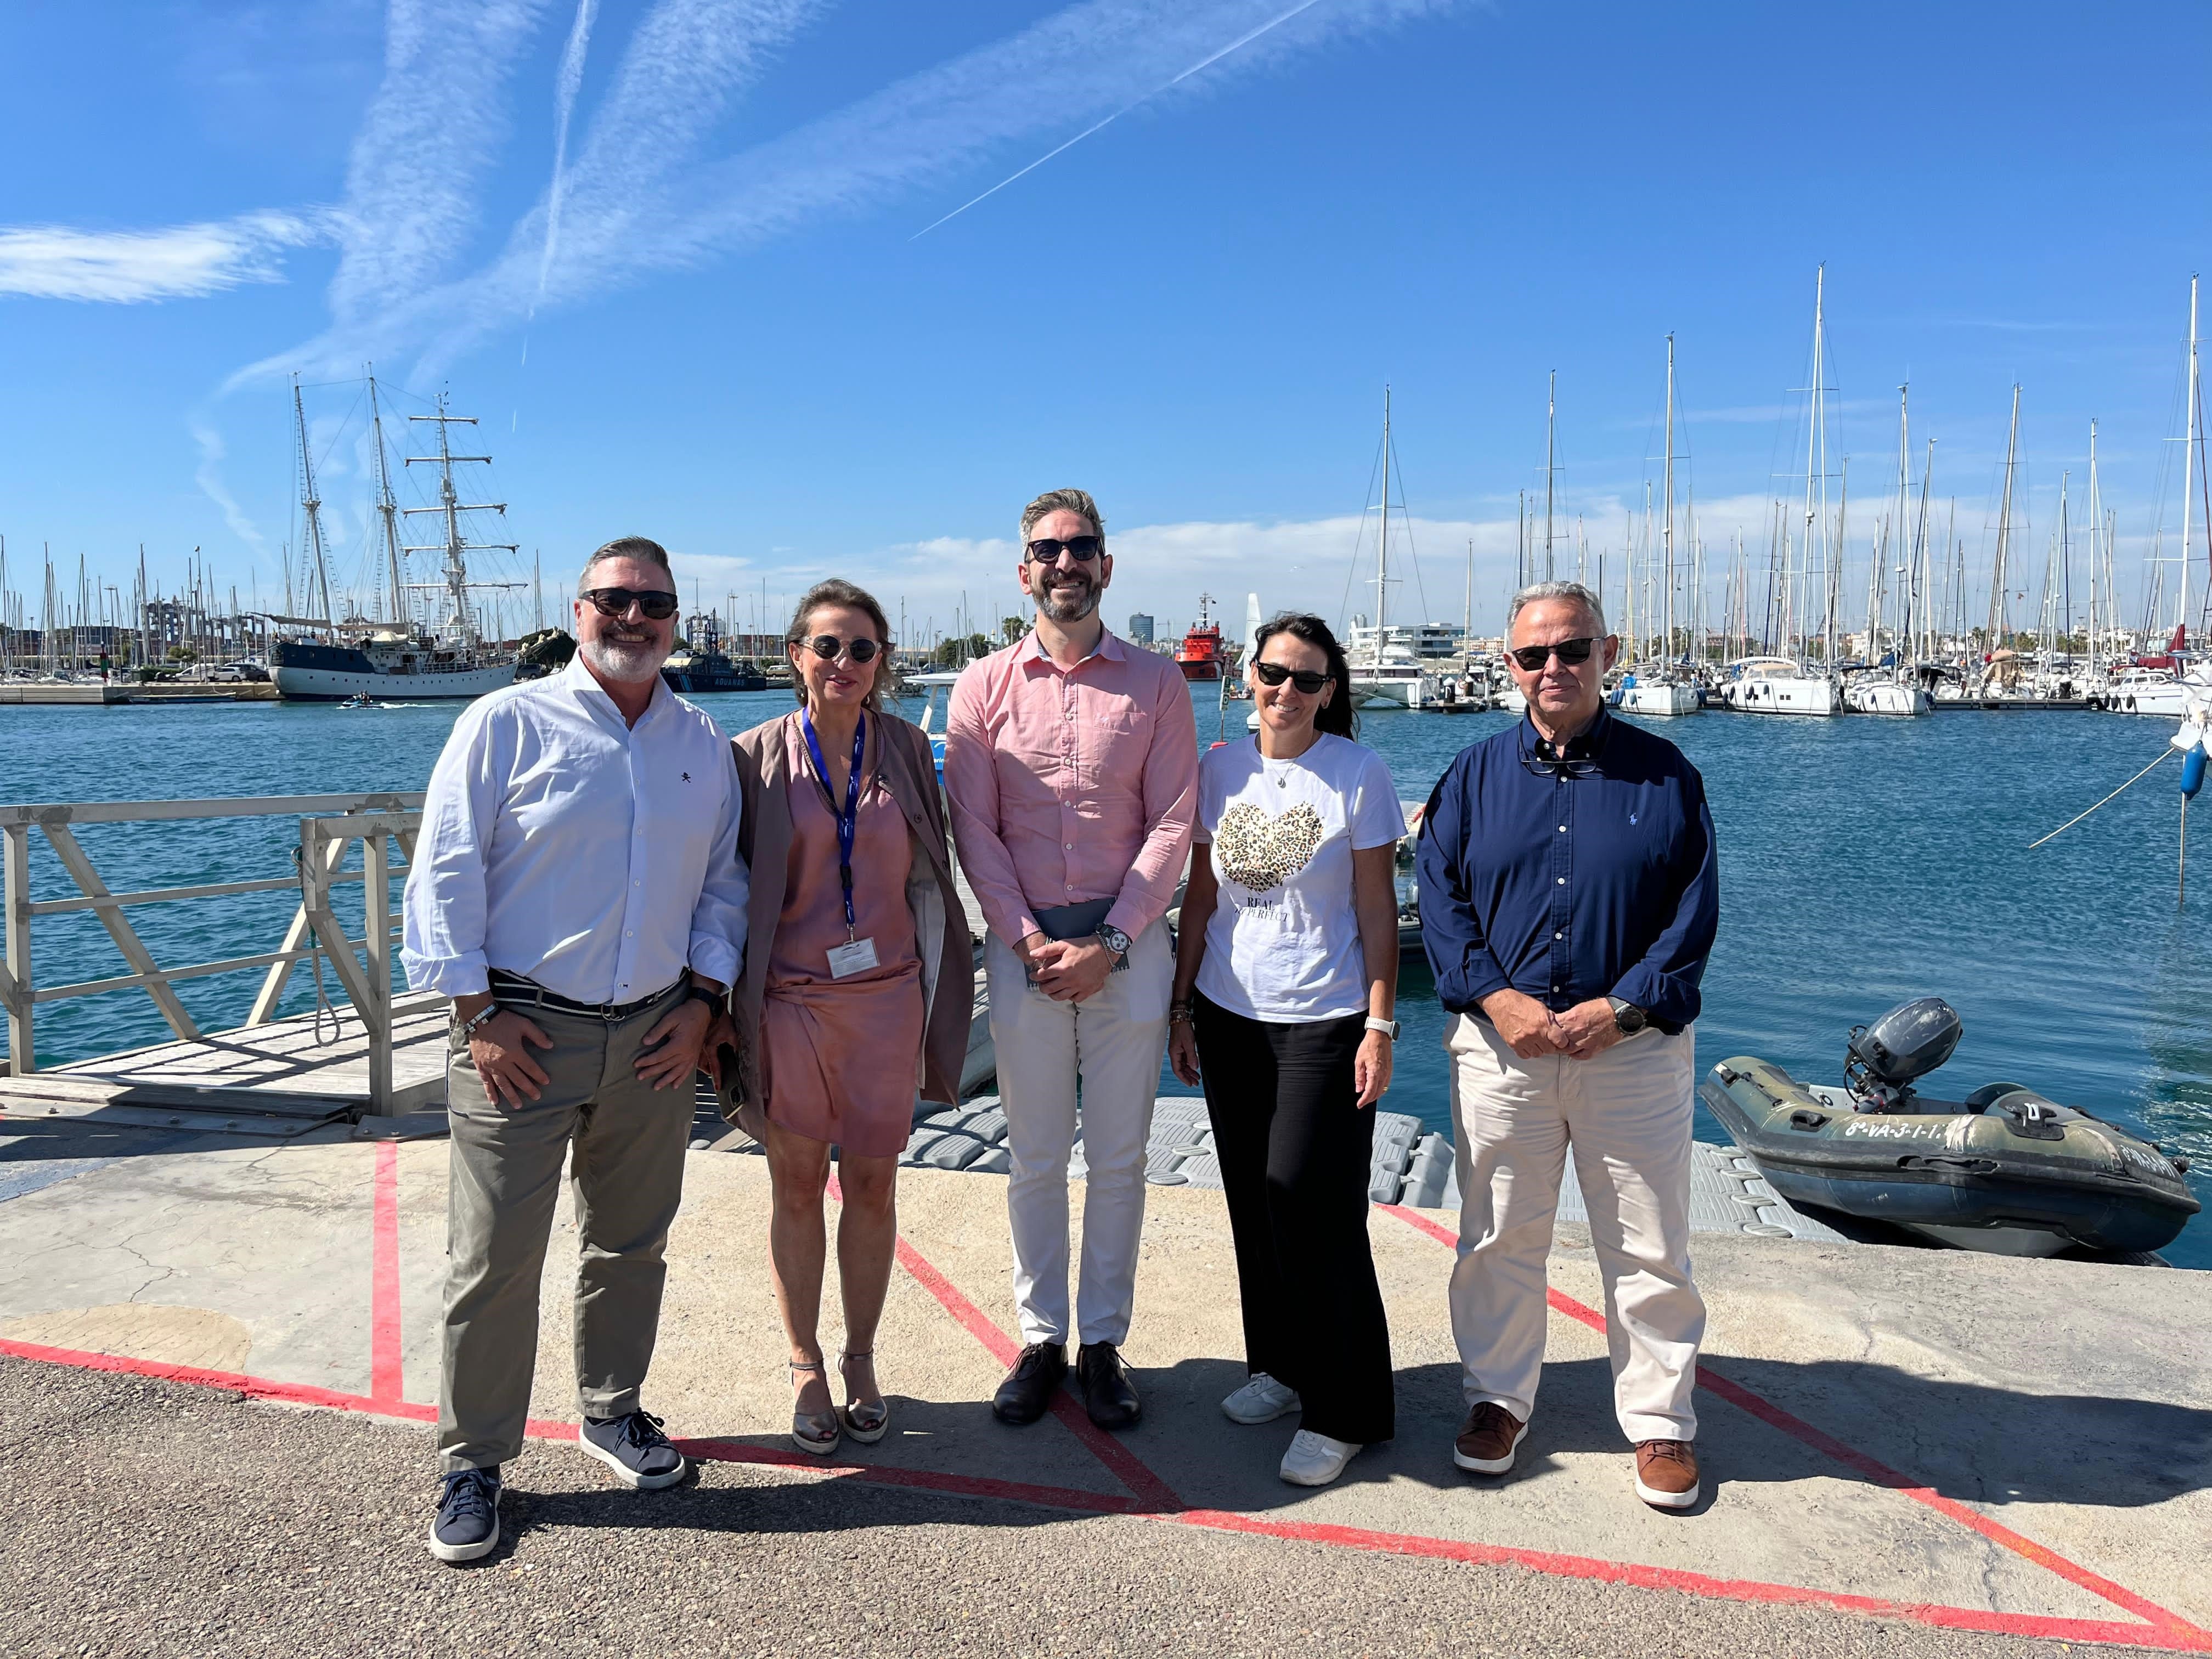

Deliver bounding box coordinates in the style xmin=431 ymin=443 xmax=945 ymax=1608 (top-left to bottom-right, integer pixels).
xmin=0 ymin=210 xmax=338 ymax=305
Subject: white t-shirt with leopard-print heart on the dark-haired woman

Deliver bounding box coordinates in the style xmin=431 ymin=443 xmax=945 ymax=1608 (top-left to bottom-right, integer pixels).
xmin=1197 ymin=735 xmax=1404 ymax=1024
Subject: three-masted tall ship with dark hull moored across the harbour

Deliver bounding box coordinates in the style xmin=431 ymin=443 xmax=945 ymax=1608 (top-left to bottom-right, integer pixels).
xmin=270 ymin=376 xmax=515 ymax=703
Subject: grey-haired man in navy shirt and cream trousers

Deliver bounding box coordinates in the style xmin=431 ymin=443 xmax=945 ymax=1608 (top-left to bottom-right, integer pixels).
xmin=1420 ymin=582 xmax=1719 ymax=1509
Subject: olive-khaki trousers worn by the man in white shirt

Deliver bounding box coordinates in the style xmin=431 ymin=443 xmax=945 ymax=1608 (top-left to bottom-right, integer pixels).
xmin=438 ymin=986 xmax=692 ymax=1473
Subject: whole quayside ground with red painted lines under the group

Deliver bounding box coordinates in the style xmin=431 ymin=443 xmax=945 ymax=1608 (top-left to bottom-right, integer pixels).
xmin=0 ymin=1115 xmax=2212 ymax=1655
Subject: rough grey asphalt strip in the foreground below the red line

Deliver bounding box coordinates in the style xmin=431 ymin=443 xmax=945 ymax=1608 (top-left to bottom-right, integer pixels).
xmin=0 ymin=1358 xmax=2106 ymax=1659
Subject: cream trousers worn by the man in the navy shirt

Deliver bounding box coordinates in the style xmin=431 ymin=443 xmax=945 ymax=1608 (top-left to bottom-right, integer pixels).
xmin=1444 ymin=1015 xmax=1706 ymax=1440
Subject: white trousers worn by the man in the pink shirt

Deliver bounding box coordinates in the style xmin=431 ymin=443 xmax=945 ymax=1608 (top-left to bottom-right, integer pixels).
xmin=984 ymin=922 xmax=1175 ymax=1347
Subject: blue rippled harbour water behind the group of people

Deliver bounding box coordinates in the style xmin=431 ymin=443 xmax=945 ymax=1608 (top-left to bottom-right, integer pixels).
xmin=0 ymin=684 xmax=2212 ymax=1267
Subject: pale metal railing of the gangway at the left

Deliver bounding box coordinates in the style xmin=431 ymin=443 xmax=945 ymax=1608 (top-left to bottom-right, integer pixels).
xmin=0 ymin=792 xmax=422 ymax=1113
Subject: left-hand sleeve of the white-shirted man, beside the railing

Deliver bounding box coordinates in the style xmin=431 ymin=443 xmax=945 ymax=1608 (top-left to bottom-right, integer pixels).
xmin=400 ymin=706 xmax=500 ymax=997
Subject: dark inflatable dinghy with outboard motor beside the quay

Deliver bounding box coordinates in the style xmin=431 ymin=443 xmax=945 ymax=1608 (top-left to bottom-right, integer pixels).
xmin=1697 ymin=997 xmax=2201 ymax=1256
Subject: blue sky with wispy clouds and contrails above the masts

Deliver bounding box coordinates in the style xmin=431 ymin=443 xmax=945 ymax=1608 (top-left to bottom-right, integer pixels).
xmin=0 ymin=0 xmax=2212 ymax=633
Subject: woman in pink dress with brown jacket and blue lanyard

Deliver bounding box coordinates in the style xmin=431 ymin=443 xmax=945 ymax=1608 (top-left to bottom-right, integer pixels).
xmin=725 ymin=582 xmax=973 ymax=1455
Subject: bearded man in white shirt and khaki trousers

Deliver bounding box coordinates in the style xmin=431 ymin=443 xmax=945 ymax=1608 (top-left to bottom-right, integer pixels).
xmin=400 ymin=535 xmax=748 ymax=1562
